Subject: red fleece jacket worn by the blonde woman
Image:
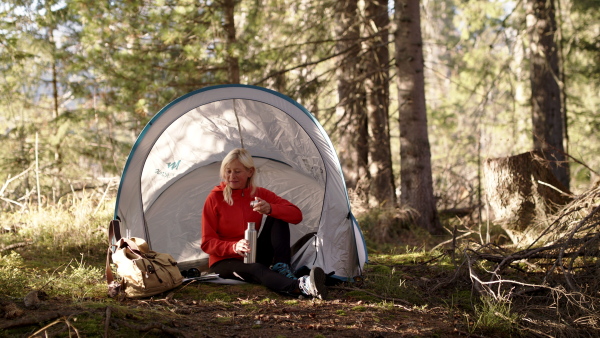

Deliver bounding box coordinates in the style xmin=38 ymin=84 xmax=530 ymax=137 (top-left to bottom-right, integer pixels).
xmin=200 ymin=182 xmax=302 ymax=266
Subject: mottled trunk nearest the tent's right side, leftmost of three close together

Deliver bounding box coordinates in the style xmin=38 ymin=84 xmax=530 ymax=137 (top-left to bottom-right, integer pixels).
xmin=335 ymin=0 xmax=370 ymax=200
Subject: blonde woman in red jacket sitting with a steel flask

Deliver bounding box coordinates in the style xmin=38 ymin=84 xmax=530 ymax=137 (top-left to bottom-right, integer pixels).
xmin=201 ymin=148 xmax=327 ymax=299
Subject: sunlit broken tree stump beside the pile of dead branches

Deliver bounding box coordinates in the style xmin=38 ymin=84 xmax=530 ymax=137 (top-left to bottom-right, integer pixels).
xmin=483 ymin=150 xmax=571 ymax=244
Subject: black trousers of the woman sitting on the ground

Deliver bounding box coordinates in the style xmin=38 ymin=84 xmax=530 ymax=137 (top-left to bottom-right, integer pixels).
xmin=210 ymin=216 xmax=298 ymax=294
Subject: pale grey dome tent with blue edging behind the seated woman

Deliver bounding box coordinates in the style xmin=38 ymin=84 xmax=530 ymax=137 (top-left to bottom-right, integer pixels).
xmin=114 ymin=85 xmax=367 ymax=280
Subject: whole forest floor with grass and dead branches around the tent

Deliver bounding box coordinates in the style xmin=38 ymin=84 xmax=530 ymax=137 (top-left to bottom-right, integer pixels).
xmin=5 ymin=180 xmax=600 ymax=338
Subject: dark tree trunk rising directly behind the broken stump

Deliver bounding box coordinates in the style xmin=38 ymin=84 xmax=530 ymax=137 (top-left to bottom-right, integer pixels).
xmin=526 ymin=0 xmax=569 ymax=188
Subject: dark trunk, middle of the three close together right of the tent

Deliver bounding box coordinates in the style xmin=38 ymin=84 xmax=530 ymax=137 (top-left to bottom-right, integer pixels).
xmin=365 ymin=0 xmax=396 ymax=207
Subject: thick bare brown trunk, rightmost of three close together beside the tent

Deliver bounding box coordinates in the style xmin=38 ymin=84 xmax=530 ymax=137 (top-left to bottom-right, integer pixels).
xmin=395 ymin=0 xmax=443 ymax=234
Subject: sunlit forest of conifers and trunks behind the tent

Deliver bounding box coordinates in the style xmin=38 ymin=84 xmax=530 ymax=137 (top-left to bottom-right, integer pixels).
xmin=0 ymin=0 xmax=600 ymax=233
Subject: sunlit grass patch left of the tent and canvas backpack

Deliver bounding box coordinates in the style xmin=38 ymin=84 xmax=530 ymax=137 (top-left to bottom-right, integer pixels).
xmin=0 ymin=194 xmax=111 ymax=301
